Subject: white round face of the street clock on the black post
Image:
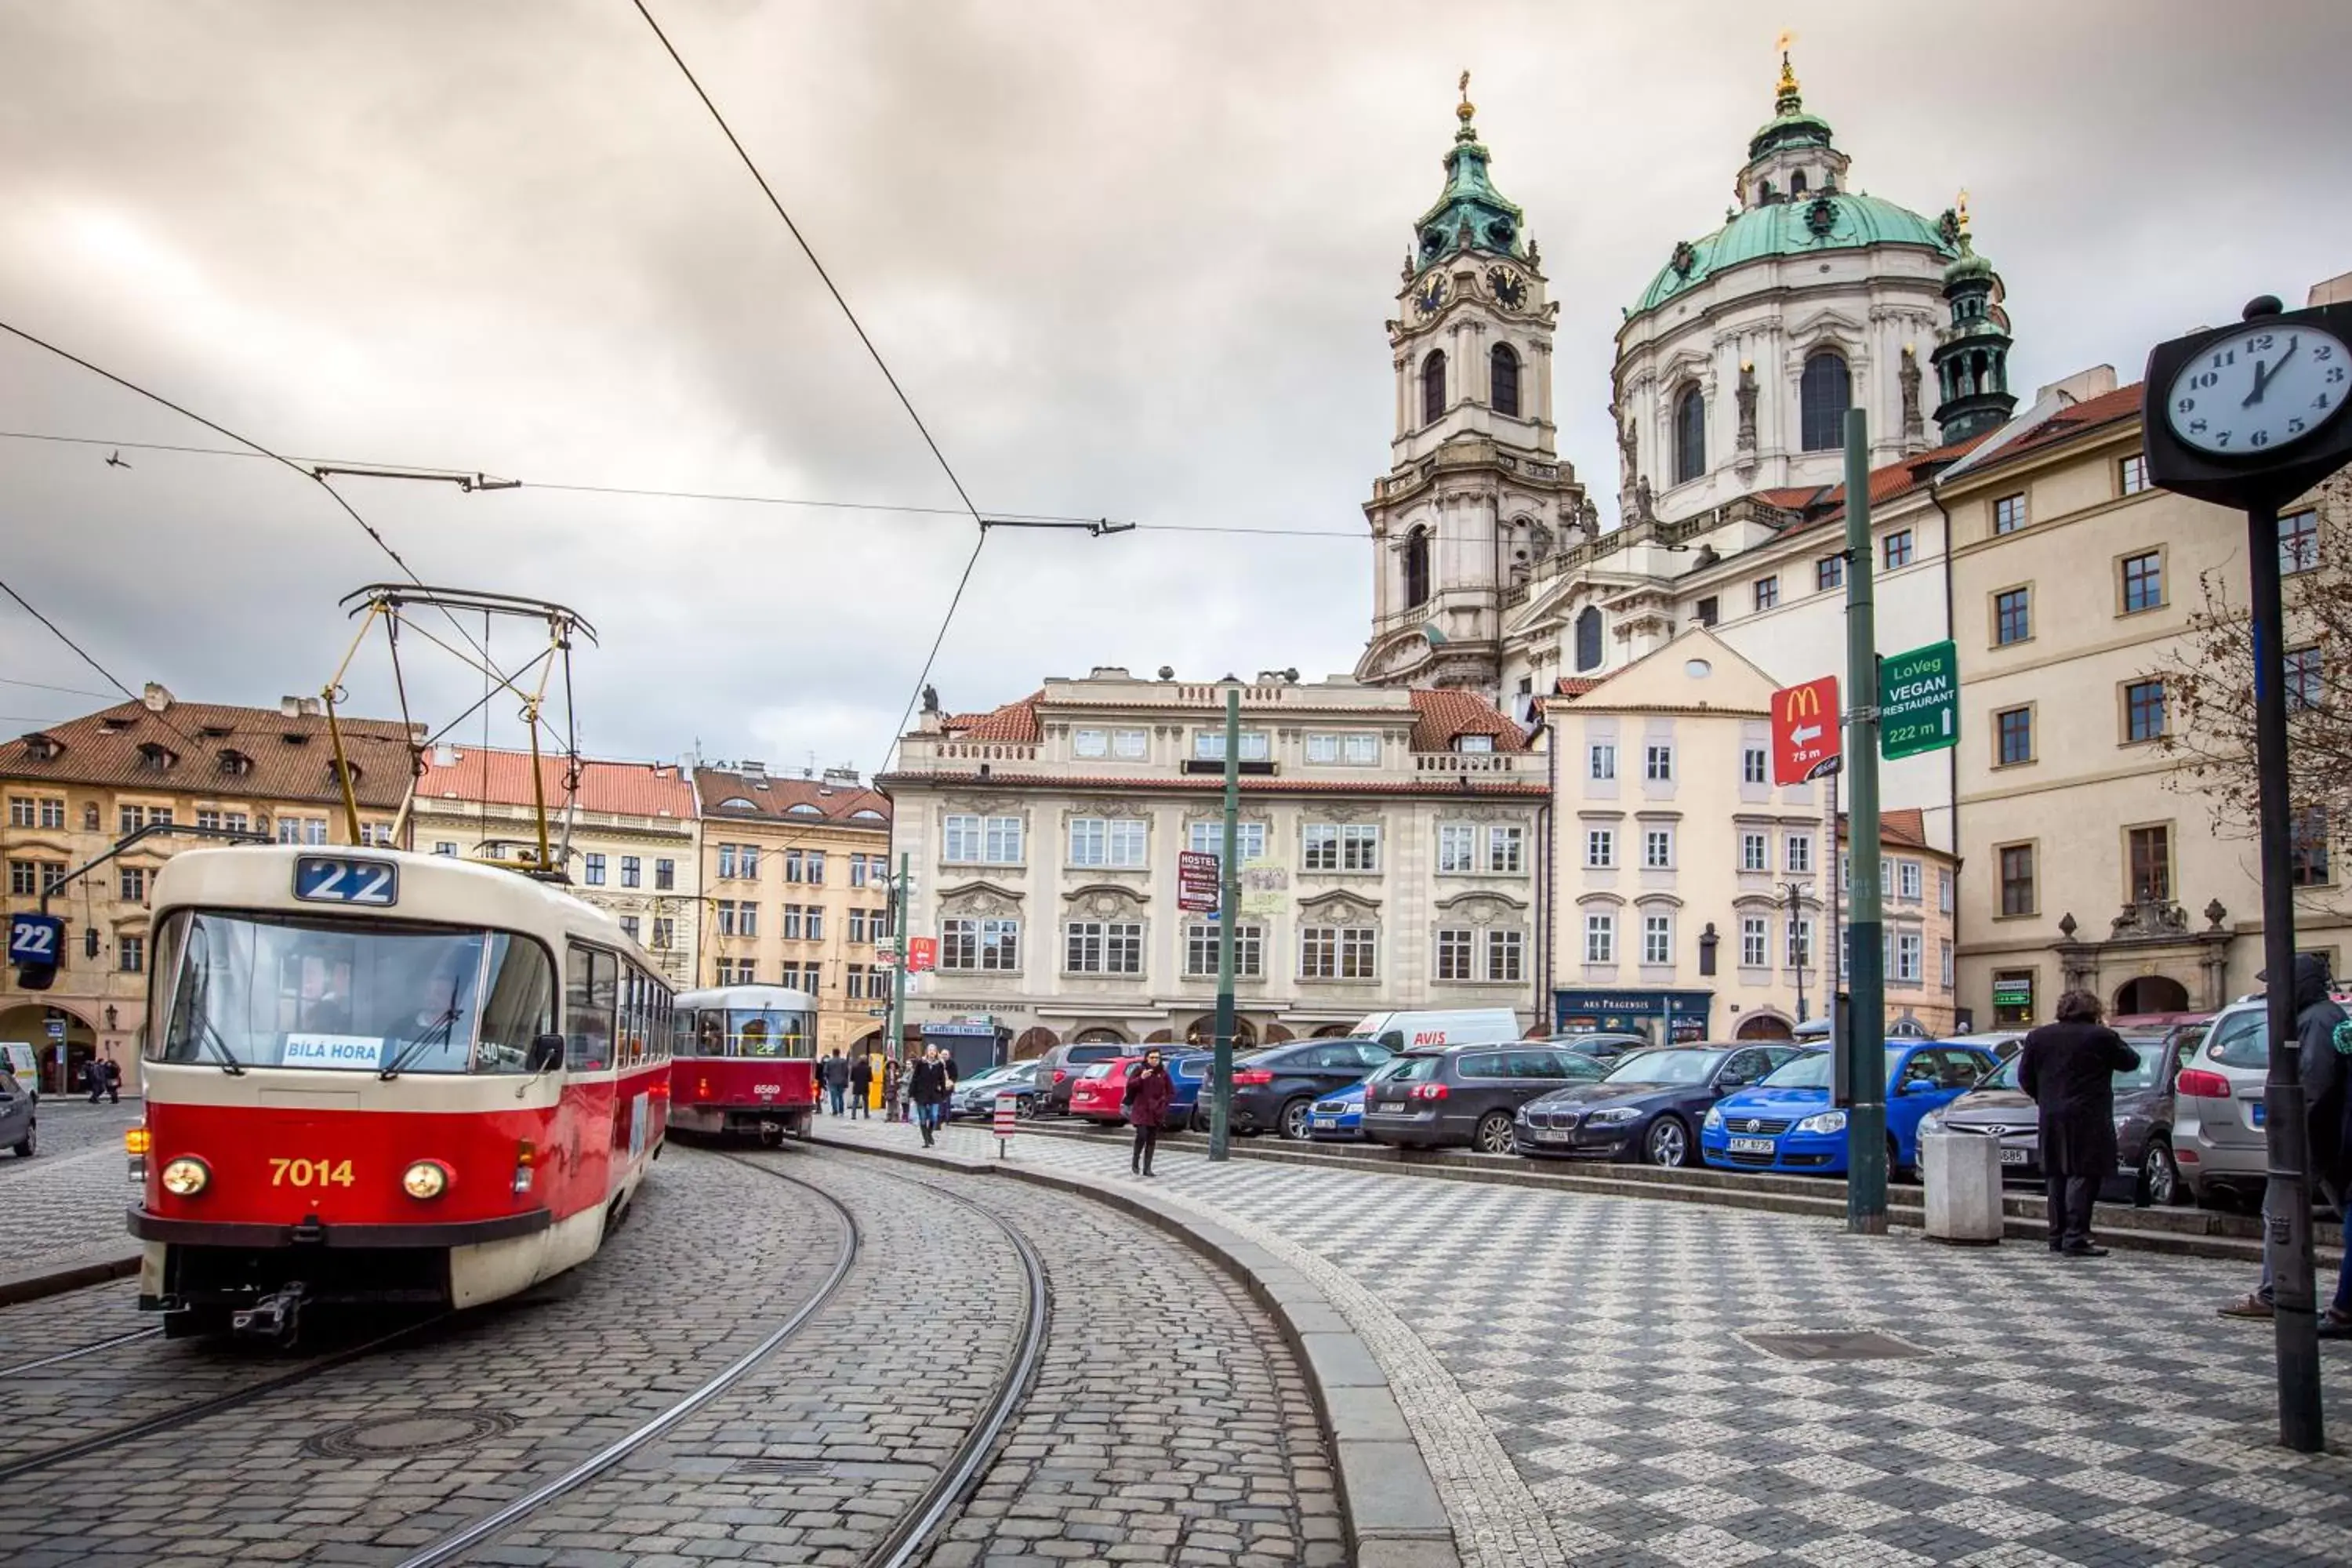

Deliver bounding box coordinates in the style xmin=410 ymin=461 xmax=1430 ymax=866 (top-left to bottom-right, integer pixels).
xmin=2164 ymin=322 xmax=2352 ymax=456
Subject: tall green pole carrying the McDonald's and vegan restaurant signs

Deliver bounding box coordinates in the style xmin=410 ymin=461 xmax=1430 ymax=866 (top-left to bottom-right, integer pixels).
xmin=1846 ymin=409 xmax=1886 ymax=1236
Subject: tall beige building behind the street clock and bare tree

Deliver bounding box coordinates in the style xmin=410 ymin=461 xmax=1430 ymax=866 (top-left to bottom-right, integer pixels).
xmin=1940 ymin=373 xmax=2352 ymax=1025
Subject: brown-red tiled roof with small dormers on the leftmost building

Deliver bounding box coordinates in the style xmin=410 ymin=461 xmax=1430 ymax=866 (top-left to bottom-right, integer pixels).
xmin=0 ymin=689 xmax=409 ymax=811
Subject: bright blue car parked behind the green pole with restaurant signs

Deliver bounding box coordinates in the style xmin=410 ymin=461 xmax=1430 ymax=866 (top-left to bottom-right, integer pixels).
xmin=1698 ymin=1039 xmax=1999 ymax=1175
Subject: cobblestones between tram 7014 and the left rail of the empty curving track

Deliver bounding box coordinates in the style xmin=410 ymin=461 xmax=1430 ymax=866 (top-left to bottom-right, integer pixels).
xmin=0 ymin=1145 xmax=837 ymax=1568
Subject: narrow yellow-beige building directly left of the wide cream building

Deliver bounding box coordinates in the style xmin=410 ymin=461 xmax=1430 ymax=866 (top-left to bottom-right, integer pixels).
xmin=694 ymin=762 xmax=891 ymax=1053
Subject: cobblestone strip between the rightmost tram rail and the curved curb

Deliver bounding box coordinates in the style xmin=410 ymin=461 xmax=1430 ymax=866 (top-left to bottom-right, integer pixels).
xmin=861 ymin=1152 xmax=1345 ymax=1568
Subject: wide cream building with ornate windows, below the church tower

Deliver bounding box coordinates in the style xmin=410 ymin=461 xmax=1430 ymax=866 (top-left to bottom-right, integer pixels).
xmin=877 ymin=668 xmax=1550 ymax=1055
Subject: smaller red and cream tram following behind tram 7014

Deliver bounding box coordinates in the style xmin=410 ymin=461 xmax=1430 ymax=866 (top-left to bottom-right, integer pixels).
xmin=670 ymin=985 xmax=816 ymax=1142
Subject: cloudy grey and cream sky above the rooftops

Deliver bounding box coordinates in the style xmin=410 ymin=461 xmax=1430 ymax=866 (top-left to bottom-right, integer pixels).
xmin=0 ymin=0 xmax=2352 ymax=769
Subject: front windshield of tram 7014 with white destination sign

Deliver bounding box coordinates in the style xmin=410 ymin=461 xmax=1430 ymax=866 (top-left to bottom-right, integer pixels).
xmin=148 ymin=912 xmax=555 ymax=1072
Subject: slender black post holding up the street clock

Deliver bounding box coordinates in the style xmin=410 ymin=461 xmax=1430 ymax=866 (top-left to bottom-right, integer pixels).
xmin=2246 ymin=506 xmax=2326 ymax=1453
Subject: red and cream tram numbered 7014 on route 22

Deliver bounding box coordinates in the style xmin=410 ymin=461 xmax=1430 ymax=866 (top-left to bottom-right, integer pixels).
xmin=129 ymin=846 xmax=673 ymax=1335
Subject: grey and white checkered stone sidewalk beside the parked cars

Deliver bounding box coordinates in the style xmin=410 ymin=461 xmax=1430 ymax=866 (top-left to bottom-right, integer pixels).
xmin=828 ymin=1126 xmax=2352 ymax=1568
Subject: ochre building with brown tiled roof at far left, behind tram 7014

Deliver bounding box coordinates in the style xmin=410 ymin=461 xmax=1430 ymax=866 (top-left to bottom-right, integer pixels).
xmin=0 ymin=682 xmax=412 ymax=1091
